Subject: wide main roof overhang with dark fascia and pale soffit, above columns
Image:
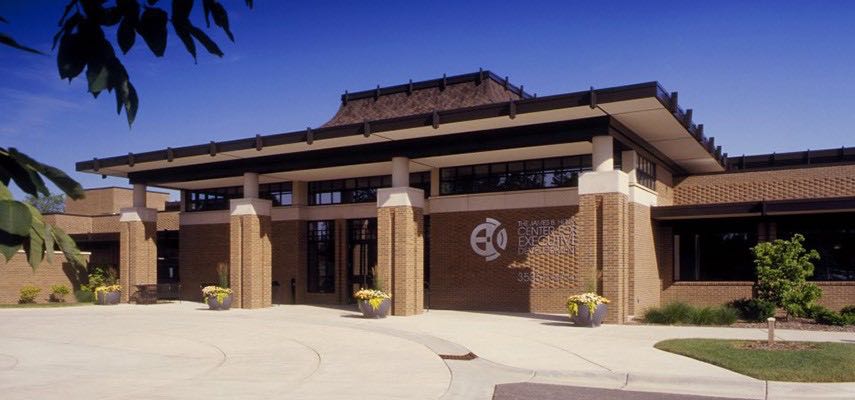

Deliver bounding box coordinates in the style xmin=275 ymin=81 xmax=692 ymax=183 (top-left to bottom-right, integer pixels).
xmin=77 ymin=82 xmax=724 ymax=186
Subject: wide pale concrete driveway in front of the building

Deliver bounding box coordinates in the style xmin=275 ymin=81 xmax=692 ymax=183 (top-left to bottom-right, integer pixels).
xmin=0 ymin=302 xmax=855 ymax=399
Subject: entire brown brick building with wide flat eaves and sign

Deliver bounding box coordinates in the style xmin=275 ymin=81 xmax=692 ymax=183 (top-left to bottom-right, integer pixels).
xmin=23 ymin=71 xmax=855 ymax=322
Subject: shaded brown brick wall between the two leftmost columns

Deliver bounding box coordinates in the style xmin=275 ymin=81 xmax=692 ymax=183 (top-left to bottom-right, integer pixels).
xmin=178 ymin=224 xmax=229 ymax=301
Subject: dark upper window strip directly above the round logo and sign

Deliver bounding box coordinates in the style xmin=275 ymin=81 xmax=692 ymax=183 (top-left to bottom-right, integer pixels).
xmin=439 ymin=155 xmax=591 ymax=194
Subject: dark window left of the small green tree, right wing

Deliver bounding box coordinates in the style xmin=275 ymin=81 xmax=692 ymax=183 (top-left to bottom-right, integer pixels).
xmin=674 ymin=221 xmax=757 ymax=281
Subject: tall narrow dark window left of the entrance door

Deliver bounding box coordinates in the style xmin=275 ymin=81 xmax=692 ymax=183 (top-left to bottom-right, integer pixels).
xmin=306 ymin=221 xmax=335 ymax=293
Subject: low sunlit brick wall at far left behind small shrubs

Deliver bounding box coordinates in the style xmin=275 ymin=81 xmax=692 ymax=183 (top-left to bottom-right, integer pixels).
xmin=0 ymin=252 xmax=86 ymax=304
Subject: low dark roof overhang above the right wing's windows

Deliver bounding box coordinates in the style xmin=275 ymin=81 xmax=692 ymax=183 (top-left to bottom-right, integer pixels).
xmin=650 ymin=197 xmax=855 ymax=221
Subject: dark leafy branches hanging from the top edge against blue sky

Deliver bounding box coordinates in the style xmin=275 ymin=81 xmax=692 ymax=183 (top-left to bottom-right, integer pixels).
xmin=0 ymin=0 xmax=253 ymax=126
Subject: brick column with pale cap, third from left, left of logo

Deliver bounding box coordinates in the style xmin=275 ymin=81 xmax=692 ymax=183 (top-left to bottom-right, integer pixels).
xmin=375 ymin=187 xmax=424 ymax=315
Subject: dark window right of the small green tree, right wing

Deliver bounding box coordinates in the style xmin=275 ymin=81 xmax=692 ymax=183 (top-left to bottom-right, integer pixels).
xmin=776 ymin=214 xmax=855 ymax=281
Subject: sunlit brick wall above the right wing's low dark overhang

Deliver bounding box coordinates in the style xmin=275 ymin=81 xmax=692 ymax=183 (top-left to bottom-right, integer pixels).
xmin=674 ymin=165 xmax=855 ymax=204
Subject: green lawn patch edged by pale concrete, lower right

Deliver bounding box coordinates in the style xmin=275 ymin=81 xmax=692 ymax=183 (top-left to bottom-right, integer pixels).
xmin=654 ymin=339 xmax=855 ymax=382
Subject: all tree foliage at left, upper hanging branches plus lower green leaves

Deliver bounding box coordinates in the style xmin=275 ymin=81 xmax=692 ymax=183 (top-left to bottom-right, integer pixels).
xmin=0 ymin=0 xmax=253 ymax=269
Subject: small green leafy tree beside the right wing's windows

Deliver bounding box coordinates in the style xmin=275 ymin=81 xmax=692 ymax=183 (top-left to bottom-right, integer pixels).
xmin=751 ymin=234 xmax=822 ymax=317
